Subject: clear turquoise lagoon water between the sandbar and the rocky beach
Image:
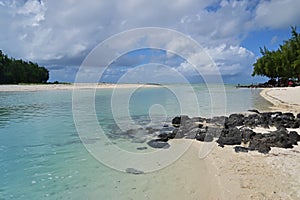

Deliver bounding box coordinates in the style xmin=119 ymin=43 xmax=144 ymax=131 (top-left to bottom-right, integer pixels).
xmin=0 ymin=85 xmax=270 ymax=200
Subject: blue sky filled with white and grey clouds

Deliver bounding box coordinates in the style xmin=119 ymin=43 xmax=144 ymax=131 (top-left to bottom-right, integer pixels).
xmin=0 ymin=0 xmax=300 ymax=83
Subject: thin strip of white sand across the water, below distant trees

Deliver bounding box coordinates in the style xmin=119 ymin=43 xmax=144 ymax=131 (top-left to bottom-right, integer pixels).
xmin=0 ymin=83 xmax=159 ymax=92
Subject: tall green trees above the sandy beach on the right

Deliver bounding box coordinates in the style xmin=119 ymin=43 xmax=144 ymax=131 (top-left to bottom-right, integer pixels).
xmin=252 ymin=27 xmax=300 ymax=84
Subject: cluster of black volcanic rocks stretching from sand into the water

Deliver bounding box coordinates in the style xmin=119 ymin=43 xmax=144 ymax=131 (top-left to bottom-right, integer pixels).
xmin=156 ymin=110 xmax=300 ymax=153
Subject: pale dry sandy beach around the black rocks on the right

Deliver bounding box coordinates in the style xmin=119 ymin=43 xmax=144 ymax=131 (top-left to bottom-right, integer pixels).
xmin=202 ymin=87 xmax=300 ymax=200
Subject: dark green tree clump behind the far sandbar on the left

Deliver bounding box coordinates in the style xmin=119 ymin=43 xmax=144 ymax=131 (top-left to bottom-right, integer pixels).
xmin=0 ymin=50 xmax=49 ymax=84
